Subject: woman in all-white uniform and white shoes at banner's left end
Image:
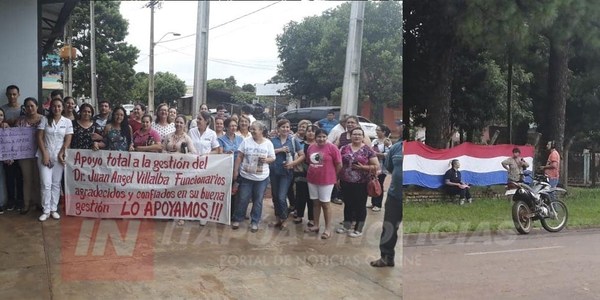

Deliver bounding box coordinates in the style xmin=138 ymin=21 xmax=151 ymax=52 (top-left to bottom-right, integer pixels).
xmin=37 ymin=99 xmax=73 ymax=222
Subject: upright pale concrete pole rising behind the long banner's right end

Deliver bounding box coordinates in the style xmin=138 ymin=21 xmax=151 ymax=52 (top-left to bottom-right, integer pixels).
xmin=192 ymin=1 xmax=210 ymax=114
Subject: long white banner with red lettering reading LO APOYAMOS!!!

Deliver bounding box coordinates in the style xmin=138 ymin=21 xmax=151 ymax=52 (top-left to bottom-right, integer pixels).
xmin=65 ymin=149 xmax=233 ymax=224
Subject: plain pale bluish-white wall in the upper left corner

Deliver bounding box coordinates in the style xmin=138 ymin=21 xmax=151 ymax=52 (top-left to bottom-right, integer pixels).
xmin=0 ymin=0 xmax=40 ymax=105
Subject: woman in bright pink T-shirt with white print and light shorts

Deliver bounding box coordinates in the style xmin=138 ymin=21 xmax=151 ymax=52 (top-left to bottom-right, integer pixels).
xmin=305 ymin=129 xmax=342 ymax=239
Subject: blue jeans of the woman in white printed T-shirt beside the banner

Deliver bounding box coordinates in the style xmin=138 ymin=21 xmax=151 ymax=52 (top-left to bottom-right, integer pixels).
xmin=233 ymin=176 xmax=269 ymax=225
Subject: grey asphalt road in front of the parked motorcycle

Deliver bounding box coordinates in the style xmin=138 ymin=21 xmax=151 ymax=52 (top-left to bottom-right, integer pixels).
xmin=402 ymin=229 xmax=600 ymax=300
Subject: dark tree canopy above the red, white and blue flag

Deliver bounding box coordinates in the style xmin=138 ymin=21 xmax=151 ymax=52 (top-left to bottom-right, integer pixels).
xmin=404 ymin=0 xmax=600 ymax=150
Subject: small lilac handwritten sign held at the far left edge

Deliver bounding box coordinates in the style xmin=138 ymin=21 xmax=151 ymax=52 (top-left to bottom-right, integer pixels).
xmin=0 ymin=127 xmax=37 ymax=161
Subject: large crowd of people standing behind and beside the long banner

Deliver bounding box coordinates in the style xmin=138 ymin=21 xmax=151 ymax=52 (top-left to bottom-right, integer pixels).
xmin=0 ymin=85 xmax=404 ymax=268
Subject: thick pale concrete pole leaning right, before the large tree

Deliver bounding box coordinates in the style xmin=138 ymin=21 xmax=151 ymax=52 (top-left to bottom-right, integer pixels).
xmin=340 ymin=1 xmax=366 ymax=118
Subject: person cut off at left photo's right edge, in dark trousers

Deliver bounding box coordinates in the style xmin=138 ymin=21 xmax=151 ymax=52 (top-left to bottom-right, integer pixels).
xmin=371 ymin=120 xmax=404 ymax=268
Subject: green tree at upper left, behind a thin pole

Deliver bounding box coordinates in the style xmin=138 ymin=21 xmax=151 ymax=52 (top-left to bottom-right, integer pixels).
xmin=71 ymin=1 xmax=139 ymax=105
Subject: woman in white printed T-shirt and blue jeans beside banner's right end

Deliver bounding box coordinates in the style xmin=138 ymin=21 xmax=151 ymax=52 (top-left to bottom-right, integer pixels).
xmin=231 ymin=121 xmax=275 ymax=232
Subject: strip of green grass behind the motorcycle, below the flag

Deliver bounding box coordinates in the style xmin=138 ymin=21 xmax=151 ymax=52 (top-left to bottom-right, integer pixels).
xmin=403 ymin=188 xmax=600 ymax=233
